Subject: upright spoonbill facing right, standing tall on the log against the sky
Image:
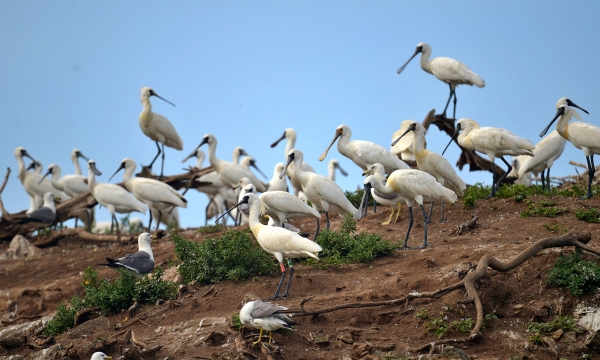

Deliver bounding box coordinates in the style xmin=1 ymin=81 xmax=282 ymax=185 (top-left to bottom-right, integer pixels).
xmin=139 ymin=87 xmax=183 ymax=177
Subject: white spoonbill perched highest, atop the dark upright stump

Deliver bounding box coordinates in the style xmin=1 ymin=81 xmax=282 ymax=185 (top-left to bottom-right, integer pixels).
xmin=398 ymin=42 xmax=485 ymax=119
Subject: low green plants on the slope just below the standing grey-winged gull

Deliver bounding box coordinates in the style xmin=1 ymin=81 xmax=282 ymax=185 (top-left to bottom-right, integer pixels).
xmin=44 ymin=266 xmax=177 ymax=336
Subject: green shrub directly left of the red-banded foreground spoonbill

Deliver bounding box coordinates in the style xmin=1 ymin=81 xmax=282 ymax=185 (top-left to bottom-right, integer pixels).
xmin=171 ymin=230 xmax=277 ymax=284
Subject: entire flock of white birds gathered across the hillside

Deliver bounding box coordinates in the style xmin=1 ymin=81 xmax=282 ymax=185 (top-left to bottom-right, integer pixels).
xmin=15 ymin=43 xmax=600 ymax=348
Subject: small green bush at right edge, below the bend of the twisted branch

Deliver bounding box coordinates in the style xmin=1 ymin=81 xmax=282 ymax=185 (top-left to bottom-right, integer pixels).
xmin=546 ymin=249 xmax=600 ymax=296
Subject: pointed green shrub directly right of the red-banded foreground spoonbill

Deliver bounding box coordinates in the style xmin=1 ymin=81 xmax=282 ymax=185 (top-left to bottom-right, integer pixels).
xmin=307 ymin=213 xmax=399 ymax=266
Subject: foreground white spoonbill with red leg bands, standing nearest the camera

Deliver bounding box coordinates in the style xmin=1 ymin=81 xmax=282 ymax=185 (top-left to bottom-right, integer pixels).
xmin=221 ymin=193 xmax=323 ymax=299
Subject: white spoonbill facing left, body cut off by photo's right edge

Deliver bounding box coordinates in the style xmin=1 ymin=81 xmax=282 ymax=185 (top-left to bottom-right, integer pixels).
xmin=540 ymin=97 xmax=600 ymax=199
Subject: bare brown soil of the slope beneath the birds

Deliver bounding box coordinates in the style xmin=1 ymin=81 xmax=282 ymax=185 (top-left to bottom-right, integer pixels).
xmin=0 ymin=197 xmax=600 ymax=359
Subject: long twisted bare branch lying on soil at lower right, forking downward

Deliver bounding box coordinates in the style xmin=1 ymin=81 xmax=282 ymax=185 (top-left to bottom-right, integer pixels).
xmin=282 ymin=232 xmax=600 ymax=352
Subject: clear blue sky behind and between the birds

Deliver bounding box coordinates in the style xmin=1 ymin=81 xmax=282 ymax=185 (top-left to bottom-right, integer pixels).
xmin=0 ymin=1 xmax=600 ymax=226
